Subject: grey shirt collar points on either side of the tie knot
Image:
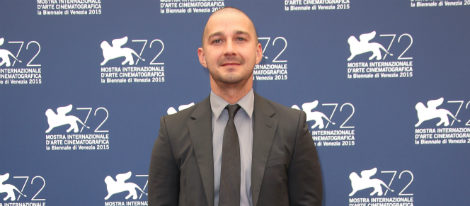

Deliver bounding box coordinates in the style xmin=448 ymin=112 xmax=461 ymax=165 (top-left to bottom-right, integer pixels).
xmin=210 ymin=89 xmax=255 ymax=119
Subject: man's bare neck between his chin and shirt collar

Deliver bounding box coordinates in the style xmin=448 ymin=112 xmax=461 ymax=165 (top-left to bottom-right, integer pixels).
xmin=211 ymin=78 xmax=253 ymax=104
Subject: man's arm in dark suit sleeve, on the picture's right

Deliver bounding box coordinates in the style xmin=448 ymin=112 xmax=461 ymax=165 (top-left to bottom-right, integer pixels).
xmin=288 ymin=111 xmax=323 ymax=206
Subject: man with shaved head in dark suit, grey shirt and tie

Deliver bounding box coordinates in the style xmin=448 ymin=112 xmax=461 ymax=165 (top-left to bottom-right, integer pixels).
xmin=148 ymin=7 xmax=322 ymax=206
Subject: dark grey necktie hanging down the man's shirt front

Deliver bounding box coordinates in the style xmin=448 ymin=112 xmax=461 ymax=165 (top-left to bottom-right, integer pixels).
xmin=219 ymin=104 xmax=240 ymax=206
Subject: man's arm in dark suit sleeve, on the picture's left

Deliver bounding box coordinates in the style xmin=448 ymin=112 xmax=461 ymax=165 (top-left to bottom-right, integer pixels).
xmin=148 ymin=117 xmax=180 ymax=206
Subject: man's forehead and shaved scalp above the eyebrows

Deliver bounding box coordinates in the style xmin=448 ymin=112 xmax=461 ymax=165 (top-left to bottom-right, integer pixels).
xmin=203 ymin=9 xmax=255 ymax=39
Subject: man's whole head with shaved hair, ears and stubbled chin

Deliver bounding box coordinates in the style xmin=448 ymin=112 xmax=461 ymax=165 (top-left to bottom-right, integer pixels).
xmin=198 ymin=9 xmax=262 ymax=85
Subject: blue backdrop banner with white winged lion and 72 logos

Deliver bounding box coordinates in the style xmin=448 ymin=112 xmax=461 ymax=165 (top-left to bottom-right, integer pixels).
xmin=0 ymin=0 xmax=470 ymax=206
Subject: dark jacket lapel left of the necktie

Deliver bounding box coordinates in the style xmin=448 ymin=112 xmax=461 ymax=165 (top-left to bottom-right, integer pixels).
xmin=188 ymin=98 xmax=214 ymax=206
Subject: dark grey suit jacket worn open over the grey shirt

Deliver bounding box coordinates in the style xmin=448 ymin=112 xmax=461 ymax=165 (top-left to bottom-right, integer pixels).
xmin=148 ymin=94 xmax=322 ymax=206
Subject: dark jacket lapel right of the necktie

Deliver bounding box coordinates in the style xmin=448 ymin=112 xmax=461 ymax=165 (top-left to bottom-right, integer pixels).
xmin=251 ymin=93 xmax=278 ymax=206
